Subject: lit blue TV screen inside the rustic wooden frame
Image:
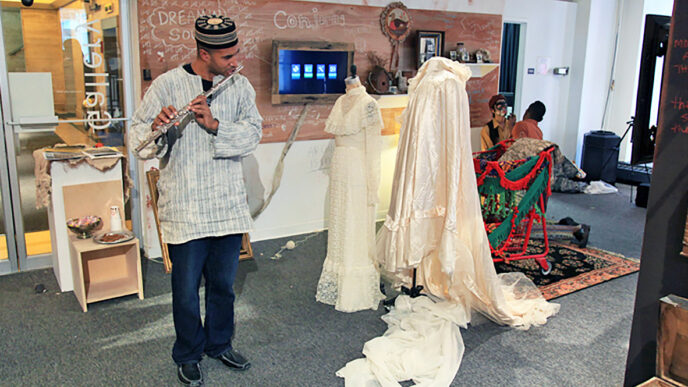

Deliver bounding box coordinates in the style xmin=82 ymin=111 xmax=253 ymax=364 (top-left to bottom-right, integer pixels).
xmin=278 ymin=49 xmax=349 ymax=94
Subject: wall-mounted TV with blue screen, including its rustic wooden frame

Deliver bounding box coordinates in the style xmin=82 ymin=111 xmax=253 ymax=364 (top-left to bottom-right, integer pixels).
xmin=272 ymin=40 xmax=354 ymax=105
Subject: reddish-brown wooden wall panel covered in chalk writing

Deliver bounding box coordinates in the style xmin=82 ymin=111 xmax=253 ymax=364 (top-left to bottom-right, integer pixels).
xmin=138 ymin=0 xmax=502 ymax=142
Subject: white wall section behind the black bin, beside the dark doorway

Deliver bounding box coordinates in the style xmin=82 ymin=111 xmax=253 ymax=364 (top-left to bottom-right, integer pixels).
xmin=568 ymin=0 xmax=673 ymax=161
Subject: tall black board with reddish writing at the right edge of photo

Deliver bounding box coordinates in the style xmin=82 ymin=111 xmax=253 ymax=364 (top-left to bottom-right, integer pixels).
xmin=624 ymin=0 xmax=688 ymax=386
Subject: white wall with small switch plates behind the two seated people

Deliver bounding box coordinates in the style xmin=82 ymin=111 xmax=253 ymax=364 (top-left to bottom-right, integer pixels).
xmin=504 ymin=0 xmax=577 ymax=158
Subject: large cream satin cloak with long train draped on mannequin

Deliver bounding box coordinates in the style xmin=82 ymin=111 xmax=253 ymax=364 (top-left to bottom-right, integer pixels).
xmin=377 ymin=57 xmax=558 ymax=327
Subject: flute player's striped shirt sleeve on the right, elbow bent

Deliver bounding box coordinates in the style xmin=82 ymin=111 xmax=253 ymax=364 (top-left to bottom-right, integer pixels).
xmin=214 ymin=77 xmax=263 ymax=158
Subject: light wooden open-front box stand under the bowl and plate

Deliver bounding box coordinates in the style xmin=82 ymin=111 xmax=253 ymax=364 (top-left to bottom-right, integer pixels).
xmin=70 ymin=236 xmax=143 ymax=312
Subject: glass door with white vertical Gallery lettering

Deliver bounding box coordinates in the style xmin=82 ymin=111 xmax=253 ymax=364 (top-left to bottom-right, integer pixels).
xmin=0 ymin=0 xmax=133 ymax=274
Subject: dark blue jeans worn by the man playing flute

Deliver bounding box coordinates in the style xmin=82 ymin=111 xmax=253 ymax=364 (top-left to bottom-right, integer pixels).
xmin=168 ymin=234 xmax=242 ymax=364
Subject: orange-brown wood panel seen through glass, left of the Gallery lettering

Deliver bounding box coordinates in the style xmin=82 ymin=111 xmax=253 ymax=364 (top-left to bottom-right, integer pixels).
xmin=21 ymin=8 xmax=66 ymax=113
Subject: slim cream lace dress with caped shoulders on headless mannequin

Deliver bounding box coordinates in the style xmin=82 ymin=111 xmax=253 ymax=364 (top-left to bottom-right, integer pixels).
xmin=315 ymin=86 xmax=384 ymax=312
